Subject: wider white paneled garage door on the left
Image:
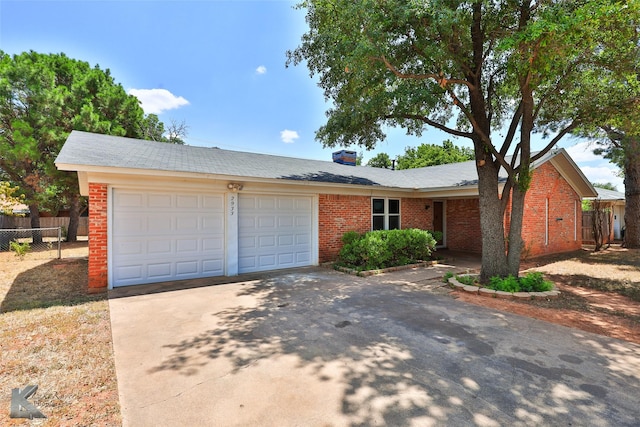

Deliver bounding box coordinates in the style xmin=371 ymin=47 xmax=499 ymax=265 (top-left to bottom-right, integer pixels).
xmin=111 ymin=189 xmax=224 ymax=286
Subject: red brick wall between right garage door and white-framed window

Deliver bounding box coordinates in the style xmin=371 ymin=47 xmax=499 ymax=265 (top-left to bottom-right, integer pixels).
xmin=318 ymin=194 xmax=370 ymax=262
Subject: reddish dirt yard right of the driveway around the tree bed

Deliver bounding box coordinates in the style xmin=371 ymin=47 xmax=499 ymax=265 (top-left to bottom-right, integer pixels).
xmin=455 ymin=247 xmax=640 ymax=344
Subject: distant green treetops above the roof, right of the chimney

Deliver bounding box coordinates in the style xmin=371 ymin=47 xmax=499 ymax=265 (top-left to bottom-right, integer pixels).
xmin=398 ymin=140 xmax=474 ymax=169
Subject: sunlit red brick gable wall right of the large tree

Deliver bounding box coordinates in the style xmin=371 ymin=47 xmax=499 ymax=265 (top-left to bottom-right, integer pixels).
xmin=522 ymin=162 xmax=582 ymax=256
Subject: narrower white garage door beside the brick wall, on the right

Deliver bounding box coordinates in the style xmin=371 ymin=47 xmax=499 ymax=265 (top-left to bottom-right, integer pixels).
xmin=238 ymin=194 xmax=313 ymax=273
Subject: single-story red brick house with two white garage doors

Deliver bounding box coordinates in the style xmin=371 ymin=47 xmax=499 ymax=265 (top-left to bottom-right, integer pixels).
xmin=56 ymin=131 xmax=596 ymax=290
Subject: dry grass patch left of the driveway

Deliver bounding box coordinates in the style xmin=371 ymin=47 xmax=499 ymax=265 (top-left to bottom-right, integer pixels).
xmin=0 ymin=242 xmax=121 ymax=426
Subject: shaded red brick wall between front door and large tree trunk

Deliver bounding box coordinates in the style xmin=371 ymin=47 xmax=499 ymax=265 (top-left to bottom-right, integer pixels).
xmin=445 ymin=199 xmax=482 ymax=253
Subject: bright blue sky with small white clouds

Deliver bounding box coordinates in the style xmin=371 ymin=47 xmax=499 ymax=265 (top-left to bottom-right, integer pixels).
xmin=0 ymin=0 xmax=624 ymax=191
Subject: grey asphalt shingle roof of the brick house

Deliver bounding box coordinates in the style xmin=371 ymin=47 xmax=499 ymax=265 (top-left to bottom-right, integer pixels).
xmin=56 ymin=131 xmax=549 ymax=189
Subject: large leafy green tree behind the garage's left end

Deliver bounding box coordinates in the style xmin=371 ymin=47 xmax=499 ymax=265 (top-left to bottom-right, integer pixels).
xmin=0 ymin=51 xmax=143 ymax=241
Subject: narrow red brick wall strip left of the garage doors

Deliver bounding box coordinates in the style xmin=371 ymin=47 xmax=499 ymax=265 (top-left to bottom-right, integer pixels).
xmin=89 ymin=183 xmax=108 ymax=292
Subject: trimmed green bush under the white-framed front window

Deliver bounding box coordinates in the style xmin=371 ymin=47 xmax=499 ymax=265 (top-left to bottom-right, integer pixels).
xmin=337 ymin=228 xmax=436 ymax=271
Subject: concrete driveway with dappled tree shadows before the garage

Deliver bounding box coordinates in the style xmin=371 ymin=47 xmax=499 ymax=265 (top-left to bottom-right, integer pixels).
xmin=109 ymin=267 xmax=640 ymax=426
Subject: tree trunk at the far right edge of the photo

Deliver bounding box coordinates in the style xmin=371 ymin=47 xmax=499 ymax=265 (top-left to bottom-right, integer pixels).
xmin=624 ymin=137 xmax=640 ymax=248
